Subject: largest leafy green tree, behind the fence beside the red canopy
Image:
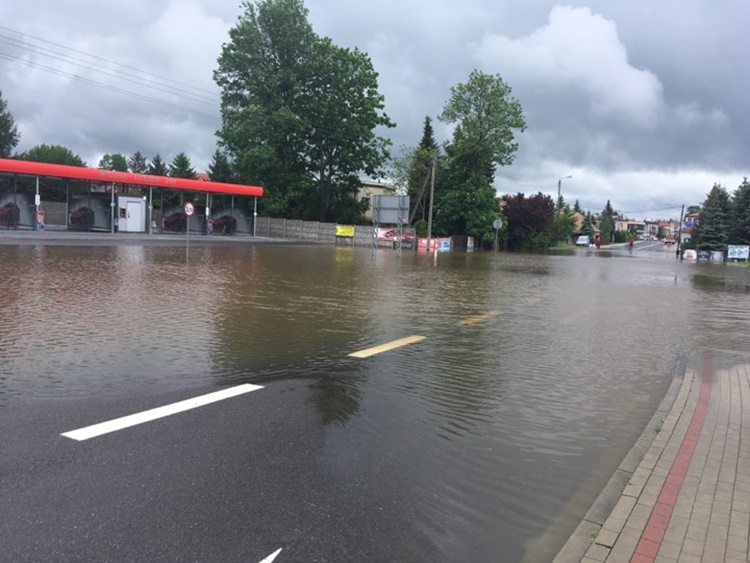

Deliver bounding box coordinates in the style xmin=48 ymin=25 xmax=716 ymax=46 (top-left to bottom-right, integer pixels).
xmin=214 ymin=0 xmax=393 ymax=220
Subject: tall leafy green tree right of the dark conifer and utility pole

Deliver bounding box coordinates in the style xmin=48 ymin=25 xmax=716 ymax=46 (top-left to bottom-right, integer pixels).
xmin=435 ymin=70 xmax=526 ymax=238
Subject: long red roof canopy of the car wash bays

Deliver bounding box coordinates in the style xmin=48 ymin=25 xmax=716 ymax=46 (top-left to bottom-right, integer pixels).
xmin=0 ymin=158 xmax=263 ymax=196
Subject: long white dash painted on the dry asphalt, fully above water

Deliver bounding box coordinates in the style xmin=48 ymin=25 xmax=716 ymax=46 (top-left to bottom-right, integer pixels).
xmin=62 ymin=383 xmax=263 ymax=441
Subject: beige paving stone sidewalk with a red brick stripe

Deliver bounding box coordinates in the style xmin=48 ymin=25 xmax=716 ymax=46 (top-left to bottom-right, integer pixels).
xmin=556 ymin=360 xmax=750 ymax=563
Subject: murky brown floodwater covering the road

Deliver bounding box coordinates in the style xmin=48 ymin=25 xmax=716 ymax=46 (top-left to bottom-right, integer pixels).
xmin=0 ymin=245 xmax=750 ymax=561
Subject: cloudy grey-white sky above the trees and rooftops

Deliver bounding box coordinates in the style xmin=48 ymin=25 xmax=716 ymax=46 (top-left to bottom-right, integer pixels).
xmin=0 ymin=0 xmax=750 ymax=218
